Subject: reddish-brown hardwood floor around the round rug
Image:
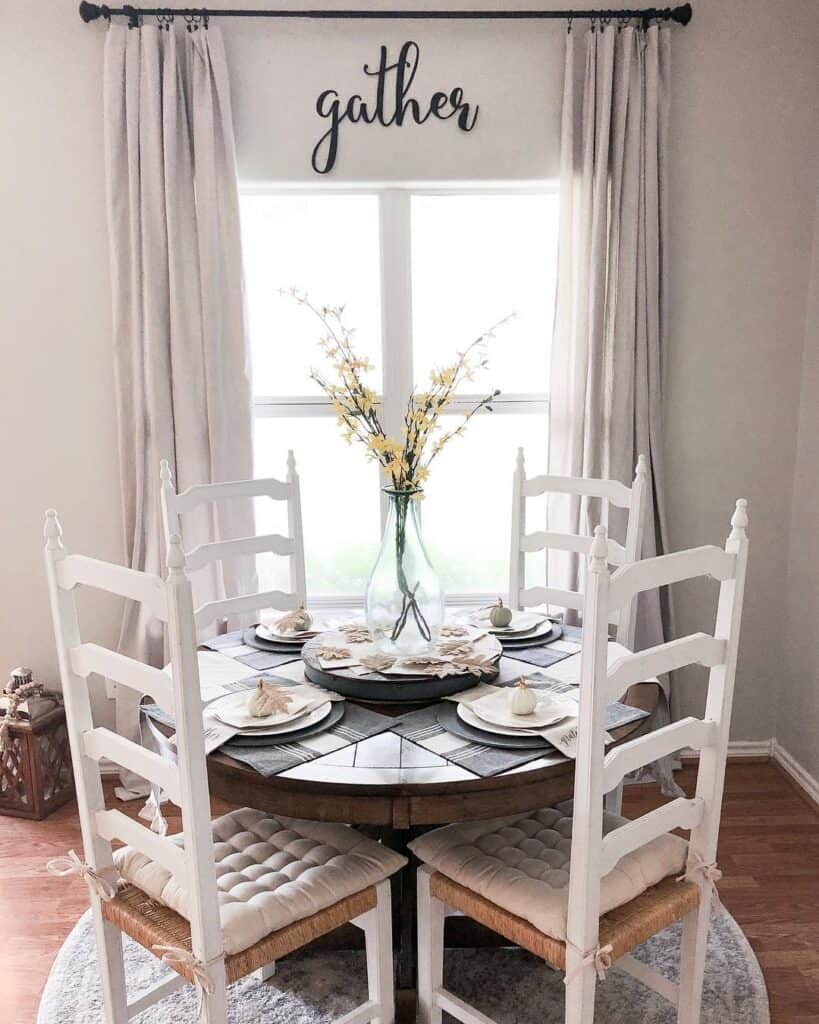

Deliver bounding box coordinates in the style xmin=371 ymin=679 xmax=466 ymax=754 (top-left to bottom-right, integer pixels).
xmin=0 ymin=761 xmax=819 ymax=1024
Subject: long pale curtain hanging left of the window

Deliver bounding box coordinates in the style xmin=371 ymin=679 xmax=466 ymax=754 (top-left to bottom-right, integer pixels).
xmin=103 ymin=25 xmax=255 ymax=781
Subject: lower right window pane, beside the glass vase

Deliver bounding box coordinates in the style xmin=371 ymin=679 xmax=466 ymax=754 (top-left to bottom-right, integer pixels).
xmin=422 ymin=412 xmax=547 ymax=595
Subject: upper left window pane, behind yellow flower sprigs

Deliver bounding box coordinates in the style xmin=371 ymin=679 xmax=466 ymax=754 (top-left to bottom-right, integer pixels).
xmin=242 ymin=194 xmax=381 ymax=395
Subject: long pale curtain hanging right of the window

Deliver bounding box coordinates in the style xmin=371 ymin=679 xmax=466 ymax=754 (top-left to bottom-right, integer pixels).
xmin=549 ymin=25 xmax=673 ymax=787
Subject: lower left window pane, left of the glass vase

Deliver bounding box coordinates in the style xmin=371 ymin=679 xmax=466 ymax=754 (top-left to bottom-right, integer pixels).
xmin=255 ymin=416 xmax=381 ymax=598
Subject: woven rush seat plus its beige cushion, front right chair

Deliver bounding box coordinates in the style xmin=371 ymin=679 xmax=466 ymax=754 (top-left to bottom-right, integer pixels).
xmin=410 ymin=802 xmax=687 ymax=954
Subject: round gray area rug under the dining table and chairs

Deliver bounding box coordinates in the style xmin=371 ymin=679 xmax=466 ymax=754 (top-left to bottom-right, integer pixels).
xmin=37 ymin=911 xmax=770 ymax=1024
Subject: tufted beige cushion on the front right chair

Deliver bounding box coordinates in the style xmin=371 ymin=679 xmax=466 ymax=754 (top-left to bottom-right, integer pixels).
xmin=410 ymin=802 xmax=688 ymax=940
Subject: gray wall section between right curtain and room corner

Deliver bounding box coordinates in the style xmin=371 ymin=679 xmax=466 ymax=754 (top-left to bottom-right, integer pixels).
xmin=665 ymin=0 xmax=819 ymax=739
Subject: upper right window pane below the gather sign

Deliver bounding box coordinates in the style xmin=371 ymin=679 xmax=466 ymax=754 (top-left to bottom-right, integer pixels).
xmin=412 ymin=194 xmax=558 ymax=394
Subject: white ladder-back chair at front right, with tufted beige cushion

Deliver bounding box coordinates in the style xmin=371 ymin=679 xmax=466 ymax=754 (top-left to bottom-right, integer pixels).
xmin=410 ymin=500 xmax=748 ymax=1024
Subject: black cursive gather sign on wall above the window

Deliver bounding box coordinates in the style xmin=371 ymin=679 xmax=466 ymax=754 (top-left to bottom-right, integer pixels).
xmin=311 ymin=40 xmax=480 ymax=174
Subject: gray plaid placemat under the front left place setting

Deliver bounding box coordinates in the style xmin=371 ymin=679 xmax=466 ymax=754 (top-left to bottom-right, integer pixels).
xmin=221 ymin=701 xmax=395 ymax=776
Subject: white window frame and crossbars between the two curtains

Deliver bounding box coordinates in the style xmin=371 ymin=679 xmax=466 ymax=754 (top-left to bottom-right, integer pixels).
xmin=240 ymin=181 xmax=558 ymax=608
